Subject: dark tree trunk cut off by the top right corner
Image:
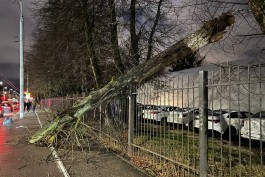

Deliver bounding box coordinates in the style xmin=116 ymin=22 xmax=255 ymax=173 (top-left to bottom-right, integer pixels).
xmin=248 ymin=0 xmax=265 ymax=34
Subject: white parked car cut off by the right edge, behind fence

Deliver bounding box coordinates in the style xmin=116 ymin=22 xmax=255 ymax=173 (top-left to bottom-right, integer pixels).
xmin=241 ymin=111 xmax=265 ymax=141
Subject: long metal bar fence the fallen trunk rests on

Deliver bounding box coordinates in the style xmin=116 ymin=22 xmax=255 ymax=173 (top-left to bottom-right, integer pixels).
xmin=41 ymin=64 xmax=265 ymax=177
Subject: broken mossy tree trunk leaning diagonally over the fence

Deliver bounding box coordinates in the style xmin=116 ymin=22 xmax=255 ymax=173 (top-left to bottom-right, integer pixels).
xmin=29 ymin=12 xmax=234 ymax=143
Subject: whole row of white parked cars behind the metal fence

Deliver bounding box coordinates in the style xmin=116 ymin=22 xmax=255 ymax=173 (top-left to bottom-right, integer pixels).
xmin=137 ymin=103 xmax=265 ymax=142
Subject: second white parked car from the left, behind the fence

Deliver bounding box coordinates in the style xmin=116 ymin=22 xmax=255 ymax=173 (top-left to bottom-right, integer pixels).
xmin=167 ymin=108 xmax=199 ymax=126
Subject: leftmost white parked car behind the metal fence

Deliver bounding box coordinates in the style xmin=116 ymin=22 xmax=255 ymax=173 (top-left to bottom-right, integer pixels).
xmin=143 ymin=105 xmax=168 ymax=125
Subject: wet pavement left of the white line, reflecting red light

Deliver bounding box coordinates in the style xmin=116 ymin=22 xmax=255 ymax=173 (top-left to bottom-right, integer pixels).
xmin=0 ymin=113 xmax=62 ymax=177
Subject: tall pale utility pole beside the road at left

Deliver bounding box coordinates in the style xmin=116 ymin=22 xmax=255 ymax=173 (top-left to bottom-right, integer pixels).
xmin=19 ymin=0 xmax=24 ymax=119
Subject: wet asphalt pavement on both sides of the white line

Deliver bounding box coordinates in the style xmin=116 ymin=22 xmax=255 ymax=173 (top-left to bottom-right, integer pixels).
xmin=0 ymin=110 xmax=147 ymax=177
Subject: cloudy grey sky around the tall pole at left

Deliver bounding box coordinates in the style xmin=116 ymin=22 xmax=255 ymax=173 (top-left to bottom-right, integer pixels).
xmin=0 ymin=0 xmax=35 ymax=87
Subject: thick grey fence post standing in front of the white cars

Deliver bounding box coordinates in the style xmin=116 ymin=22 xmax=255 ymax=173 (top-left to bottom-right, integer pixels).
xmin=199 ymin=71 xmax=208 ymax=177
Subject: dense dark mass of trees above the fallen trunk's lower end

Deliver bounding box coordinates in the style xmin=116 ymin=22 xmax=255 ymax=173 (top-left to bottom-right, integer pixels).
xmin=26 ymin=0 xmax=112 ymax=95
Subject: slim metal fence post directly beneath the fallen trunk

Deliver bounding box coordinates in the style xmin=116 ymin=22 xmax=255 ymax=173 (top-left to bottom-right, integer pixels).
xmin=128 ymin=84 xmax=136 ymax=154
